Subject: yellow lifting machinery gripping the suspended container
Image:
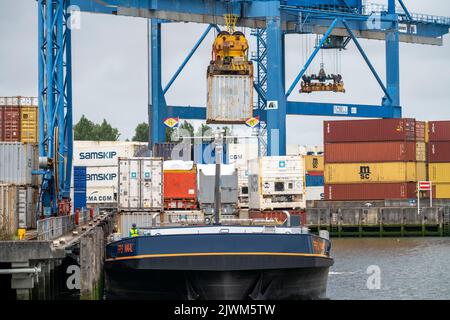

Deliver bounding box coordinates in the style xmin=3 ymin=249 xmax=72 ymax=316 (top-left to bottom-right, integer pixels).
xmin=208 ymin=15 xmax=253 ymax=76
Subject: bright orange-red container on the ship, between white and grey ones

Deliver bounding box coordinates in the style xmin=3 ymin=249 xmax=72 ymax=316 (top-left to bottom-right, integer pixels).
xmin=164 ymin=167 xmax=197 ymax=209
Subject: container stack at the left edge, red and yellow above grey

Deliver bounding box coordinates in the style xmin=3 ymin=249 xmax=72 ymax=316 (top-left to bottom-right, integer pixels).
xmin=0 ymin=97 xmax=39 ymax=239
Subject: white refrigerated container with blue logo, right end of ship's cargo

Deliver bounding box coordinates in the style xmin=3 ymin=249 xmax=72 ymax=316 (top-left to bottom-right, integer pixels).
xmin=248 ymin=156 xmax=305 ymax=210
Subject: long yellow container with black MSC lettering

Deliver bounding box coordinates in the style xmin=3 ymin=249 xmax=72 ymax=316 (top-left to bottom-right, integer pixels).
xmin=325 ymin=162 xmax=427 ymax=184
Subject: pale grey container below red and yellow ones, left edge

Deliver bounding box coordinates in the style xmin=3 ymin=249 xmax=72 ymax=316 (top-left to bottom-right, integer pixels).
xmin=0 ymin=142 xmax=39 ymax=185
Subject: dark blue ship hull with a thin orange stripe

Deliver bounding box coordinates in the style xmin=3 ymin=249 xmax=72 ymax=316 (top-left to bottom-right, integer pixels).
xmin=105 ymin=229 xmax=333 ymax=300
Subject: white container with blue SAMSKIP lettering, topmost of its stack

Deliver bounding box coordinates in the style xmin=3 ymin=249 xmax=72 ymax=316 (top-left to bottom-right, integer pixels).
xmin=73 ymin=141 xmax=147 ymax=167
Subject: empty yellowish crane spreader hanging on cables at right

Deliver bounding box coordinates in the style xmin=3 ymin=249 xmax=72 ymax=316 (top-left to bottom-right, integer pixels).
xmin=300 ymin=63 xmax=345 ymax=93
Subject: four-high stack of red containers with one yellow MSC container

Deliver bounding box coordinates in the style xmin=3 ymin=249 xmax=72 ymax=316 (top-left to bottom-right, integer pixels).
xmin=324 ymin=119 xmax=427 ymax=201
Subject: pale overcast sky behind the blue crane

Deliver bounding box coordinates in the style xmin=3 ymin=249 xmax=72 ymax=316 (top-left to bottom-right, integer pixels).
xmin=0 ymin=0 xmax=450 ymax=145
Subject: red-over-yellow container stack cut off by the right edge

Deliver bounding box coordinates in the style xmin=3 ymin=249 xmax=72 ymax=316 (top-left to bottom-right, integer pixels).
xmin=428 ymin=121 xmax=450 ymax=199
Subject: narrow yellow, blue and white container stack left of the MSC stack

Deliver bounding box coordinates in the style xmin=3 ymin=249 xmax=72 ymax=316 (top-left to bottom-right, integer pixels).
xmin=304 ymin=152 xmax=324 ymax=200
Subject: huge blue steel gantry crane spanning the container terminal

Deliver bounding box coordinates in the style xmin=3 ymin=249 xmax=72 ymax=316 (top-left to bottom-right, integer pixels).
xmin=38 ymin=0 xmax=450 ymax=215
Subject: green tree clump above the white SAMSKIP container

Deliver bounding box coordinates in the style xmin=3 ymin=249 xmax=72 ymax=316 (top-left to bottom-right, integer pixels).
xmin=74 ymin=115 xmax=120 ymax=141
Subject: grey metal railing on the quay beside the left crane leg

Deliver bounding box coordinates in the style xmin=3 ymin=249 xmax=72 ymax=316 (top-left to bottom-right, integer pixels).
xmin=37 ymin=214 xmax=75 ymax=241
